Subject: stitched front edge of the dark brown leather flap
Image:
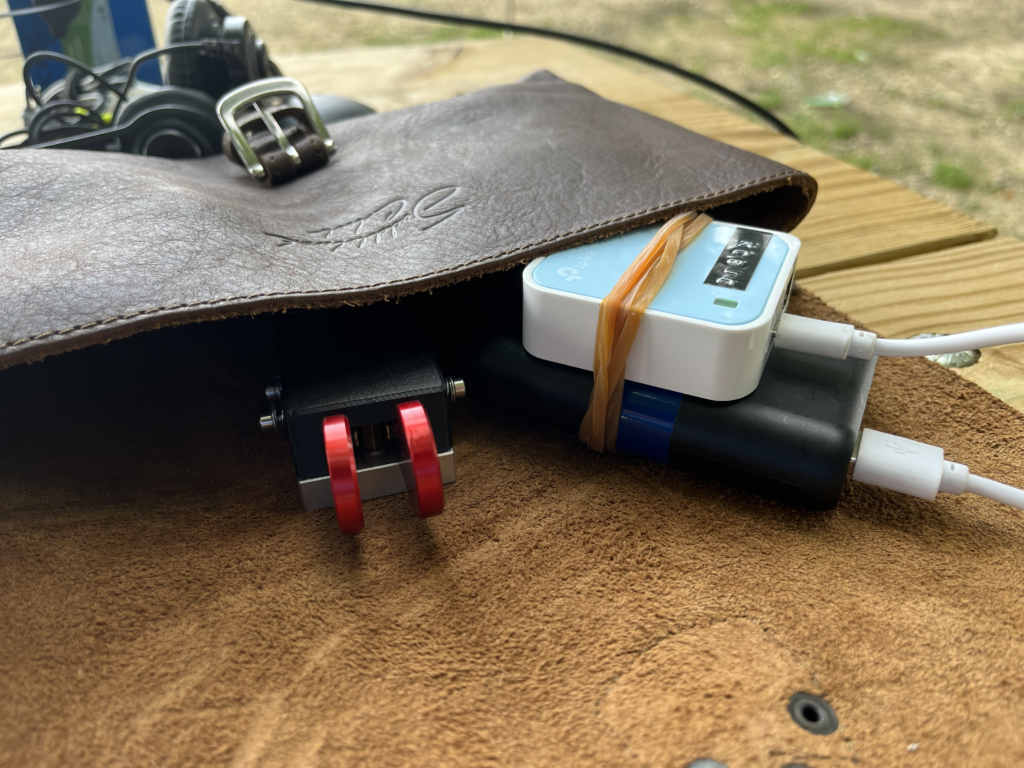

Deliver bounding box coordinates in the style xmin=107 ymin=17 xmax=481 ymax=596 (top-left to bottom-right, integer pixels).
xmin=0 ymin=169 xmax=813 ymax=354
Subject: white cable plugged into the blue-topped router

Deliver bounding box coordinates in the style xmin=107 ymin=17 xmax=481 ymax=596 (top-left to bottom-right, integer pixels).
xmin=775 ymin=314 xmax=1024 ymax=360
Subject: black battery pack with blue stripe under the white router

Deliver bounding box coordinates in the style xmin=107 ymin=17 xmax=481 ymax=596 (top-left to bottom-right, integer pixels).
xmin=470 ymin=336 xmax=876 ymax=509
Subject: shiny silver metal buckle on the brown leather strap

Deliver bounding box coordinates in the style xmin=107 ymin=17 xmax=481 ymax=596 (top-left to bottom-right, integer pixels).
xmin=217 ymin=78 xmax=338 ymax=181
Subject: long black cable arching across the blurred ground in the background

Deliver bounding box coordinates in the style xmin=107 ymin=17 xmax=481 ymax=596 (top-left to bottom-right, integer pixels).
xmin=296 ymin=0 xmax=800 ymax=140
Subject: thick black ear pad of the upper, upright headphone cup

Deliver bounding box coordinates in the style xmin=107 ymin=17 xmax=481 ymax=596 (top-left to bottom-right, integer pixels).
xmin=164 ymin=0 xmax=231 ymax=98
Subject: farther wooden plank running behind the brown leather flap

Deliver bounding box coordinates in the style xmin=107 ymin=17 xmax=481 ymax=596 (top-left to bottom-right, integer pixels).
xmin=281 ymin=38 xmax=995 ymax=276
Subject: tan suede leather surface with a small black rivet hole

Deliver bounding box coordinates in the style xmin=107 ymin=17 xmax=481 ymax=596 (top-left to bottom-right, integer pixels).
xmin=0 ymin=295 xmax=1024 ymax=768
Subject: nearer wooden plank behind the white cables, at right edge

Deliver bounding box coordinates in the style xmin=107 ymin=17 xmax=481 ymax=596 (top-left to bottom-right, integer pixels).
xmin=801 ymin=238 xmax=1024 ymax=411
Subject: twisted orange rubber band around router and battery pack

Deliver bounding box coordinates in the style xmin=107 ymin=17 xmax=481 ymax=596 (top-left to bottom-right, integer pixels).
xmin=580 ymin=211 xmax=712 ymax=453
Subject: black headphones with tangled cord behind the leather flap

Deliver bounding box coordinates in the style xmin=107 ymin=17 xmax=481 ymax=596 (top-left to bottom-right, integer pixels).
xmin=23 ymin=0 xmax=281 ymax=159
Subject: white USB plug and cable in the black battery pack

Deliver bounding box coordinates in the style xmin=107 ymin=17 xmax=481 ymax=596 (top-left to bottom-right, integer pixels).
xmin=850 ymin=429 xmax=1024 ymax=510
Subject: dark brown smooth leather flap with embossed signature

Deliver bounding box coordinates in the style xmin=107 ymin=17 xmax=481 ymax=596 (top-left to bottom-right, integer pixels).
xmin=0 ymin=74 xmax=817 ymax=368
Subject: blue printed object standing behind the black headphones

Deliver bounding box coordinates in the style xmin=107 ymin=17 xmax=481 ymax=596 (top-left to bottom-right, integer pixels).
xmin=8 ymin=0 xmax=163 ymax=88
